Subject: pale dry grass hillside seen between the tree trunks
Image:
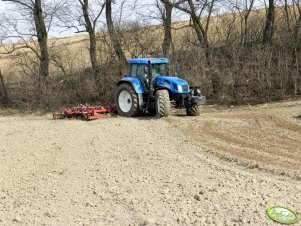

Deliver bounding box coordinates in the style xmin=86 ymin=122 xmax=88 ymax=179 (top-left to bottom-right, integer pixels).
xmin=0 ymin=6 xmax=270 ymax=75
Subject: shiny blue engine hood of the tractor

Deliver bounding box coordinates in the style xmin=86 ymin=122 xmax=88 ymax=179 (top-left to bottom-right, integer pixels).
xmin=156 ymin=76 xmax=189 ymax=93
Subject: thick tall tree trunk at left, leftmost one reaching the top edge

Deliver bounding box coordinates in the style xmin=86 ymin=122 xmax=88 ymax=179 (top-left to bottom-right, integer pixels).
xmin=33 ymin=0 xmax=49 ymax=79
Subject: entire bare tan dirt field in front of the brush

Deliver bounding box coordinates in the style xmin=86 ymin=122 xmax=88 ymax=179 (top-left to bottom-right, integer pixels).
xmin=0 ymin=101 xmax=301 ymax=225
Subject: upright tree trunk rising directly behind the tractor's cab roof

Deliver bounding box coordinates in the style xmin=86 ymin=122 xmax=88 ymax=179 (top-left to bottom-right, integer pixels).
xmin=162 ymin=3 xmax=173 ymax=57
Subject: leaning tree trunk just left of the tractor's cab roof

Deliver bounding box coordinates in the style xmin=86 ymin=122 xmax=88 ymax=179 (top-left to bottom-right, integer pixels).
xmin=106 ymin=0 xmax=127 ymax=65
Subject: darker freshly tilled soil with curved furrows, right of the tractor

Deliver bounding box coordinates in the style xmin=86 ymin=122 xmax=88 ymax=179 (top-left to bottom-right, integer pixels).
xmin=166 ymin=104 xmax=301 ymax=174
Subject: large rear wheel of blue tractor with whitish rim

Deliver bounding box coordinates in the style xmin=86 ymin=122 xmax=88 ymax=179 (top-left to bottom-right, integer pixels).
xmin=115 ymin=83 xmax=140 ymax=117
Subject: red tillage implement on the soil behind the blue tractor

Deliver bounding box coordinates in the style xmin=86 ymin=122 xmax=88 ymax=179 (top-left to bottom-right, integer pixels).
xmin=53 ymin=104 xmax=116 ymax=120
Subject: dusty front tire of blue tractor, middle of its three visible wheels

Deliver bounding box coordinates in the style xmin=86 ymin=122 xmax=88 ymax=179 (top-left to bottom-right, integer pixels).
xmin=156 ymin=89 xmax=171 ymax=118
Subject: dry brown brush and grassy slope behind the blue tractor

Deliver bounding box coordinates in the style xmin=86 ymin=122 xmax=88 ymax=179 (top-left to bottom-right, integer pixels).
xmin=0 ymin=1 xmax=301 ymax=108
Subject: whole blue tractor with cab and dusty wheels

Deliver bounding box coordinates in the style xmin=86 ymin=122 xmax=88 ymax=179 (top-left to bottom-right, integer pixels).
xmin=115 ymin=58 xmax=206 ymax=117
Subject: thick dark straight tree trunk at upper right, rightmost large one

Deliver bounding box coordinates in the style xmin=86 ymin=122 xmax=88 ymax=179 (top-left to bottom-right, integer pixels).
xmin=263 ymin=0 xmax=275 ymax=45
